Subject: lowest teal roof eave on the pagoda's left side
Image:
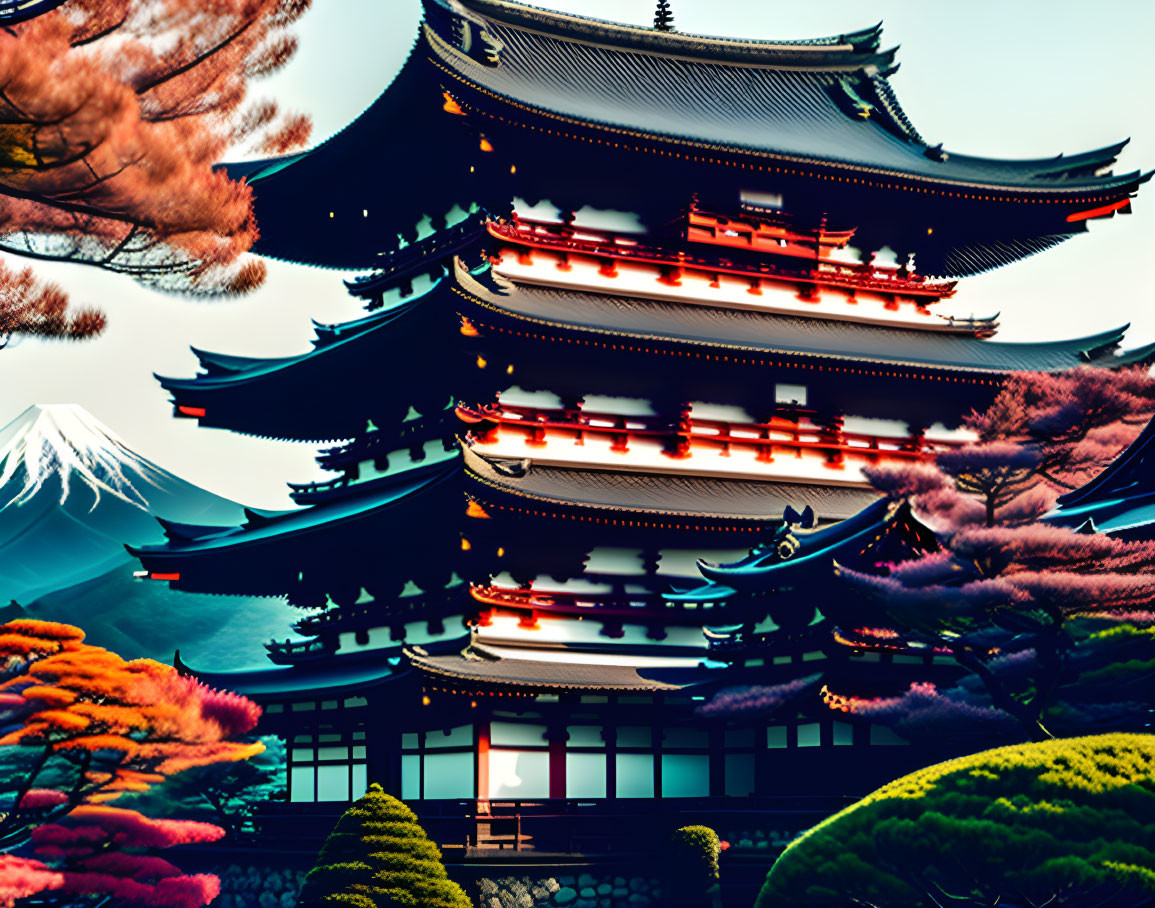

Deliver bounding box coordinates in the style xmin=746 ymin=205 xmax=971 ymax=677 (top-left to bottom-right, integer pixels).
xmin=173 ymin=648 xmax=409 ymax=699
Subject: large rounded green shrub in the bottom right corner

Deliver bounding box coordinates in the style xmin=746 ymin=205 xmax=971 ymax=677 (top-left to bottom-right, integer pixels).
xmin=757 ymin=735 xmax=1155 ymax=908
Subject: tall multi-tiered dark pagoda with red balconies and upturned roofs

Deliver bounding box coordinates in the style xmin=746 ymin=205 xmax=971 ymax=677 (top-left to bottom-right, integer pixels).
xmin=135 ymin=0 xmax=1155 ymax=850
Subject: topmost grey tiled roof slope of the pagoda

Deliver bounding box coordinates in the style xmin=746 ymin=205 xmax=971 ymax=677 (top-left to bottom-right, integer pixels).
xmin=426 ymin=0 xmax=1149 ymax=198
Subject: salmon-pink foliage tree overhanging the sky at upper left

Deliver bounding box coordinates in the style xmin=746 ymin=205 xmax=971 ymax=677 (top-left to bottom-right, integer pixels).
xmin=0 ymin=0 xmax=310 ymax=344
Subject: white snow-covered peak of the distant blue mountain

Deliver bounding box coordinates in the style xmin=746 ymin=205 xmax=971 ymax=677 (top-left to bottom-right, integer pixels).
xmin=0 ymin=403 xmax=164 ymax=511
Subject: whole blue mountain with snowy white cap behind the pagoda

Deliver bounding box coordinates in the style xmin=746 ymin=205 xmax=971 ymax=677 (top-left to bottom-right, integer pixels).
xmin=0 ymin=404 xmax=243 ymax=603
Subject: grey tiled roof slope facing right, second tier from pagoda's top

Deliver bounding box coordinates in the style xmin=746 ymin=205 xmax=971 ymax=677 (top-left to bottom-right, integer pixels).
xmin=455 ymin=266 xmax=1155 ymax=374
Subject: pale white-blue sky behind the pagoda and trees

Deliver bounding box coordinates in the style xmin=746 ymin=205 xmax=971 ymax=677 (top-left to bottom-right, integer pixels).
xmin=0 ymin=0 xmax=1155 ymax=508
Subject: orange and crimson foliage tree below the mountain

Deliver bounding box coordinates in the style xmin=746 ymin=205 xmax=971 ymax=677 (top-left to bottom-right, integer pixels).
xmin=0 ymin=619 xmax=263 ymax=908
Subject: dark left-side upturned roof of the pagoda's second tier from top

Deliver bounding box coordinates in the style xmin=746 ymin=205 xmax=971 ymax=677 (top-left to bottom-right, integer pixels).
xmin=156 ymin=281 xmax=449 ymax=441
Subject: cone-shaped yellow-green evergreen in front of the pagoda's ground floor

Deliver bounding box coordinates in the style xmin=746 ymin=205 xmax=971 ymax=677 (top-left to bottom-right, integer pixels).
xmin=299 ymin=783 xmax=471 ymax=908
